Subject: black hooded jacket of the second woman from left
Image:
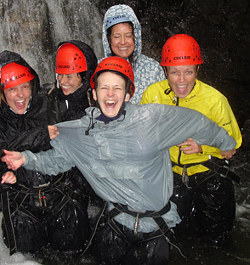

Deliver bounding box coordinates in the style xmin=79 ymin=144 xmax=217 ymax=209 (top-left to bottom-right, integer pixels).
xmin=43 ymin=40 xmax=103 ymax=223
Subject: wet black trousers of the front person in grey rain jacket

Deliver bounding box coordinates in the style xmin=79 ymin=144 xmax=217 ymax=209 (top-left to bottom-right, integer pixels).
xmin=93 ymin=219 xmax=169 ymax=265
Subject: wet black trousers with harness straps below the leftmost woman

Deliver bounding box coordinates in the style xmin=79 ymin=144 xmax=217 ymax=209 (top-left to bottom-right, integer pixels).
xmin=2 ymin=189 xmax=90 ymax=253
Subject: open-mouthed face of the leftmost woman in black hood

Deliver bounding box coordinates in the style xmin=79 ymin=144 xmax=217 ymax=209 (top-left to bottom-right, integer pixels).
xmin=3 ymin=81 xmax=32 ymax=114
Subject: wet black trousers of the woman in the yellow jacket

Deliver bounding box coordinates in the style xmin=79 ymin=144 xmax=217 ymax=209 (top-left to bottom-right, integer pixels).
xmin=171 ymin=171 xmax=235 ymax=245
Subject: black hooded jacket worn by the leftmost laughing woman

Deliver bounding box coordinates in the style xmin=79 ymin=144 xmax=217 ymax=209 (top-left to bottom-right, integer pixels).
xmin=0 ymin=51 xmax=51 ymax=187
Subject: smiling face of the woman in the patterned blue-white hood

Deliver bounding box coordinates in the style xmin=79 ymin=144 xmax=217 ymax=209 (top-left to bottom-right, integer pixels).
xmin=110 ymin=23 xmax=135 ymax=58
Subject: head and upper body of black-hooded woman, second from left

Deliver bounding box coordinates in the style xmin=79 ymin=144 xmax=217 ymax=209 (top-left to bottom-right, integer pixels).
xmin=44 ymin=40 xmax=97 ymax=123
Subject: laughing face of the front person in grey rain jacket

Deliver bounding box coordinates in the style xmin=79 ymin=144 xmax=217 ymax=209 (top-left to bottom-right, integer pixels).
xmin=93 ymin=72 xmax=130 ymax=118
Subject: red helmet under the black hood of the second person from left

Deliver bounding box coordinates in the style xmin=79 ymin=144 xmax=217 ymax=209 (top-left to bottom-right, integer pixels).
xmin=56 ymin=43 xmax=87 ymax=74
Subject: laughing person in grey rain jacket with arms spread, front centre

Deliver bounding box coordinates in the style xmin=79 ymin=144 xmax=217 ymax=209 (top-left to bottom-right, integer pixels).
xmin=2 ymin=57 xmax=235 ymax=265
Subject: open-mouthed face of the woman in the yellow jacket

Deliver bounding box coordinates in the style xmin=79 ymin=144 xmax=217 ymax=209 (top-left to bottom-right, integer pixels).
xmin=166 ymin=65 xmax=197 ymax=98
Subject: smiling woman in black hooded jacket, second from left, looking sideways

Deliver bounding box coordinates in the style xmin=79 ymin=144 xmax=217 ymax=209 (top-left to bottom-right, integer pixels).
xmin=45 ymin=40 xmax=103 ymax=231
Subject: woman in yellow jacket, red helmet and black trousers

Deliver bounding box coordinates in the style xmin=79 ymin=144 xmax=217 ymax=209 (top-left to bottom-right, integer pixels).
xmin=141 ymin=34 xmax=242 ymax=244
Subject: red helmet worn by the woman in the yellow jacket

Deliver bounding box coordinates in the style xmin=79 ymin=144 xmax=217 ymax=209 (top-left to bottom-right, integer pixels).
xmin=161 ymin=34 xmax=203 ymax=66
